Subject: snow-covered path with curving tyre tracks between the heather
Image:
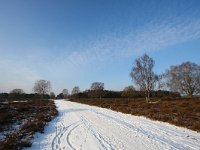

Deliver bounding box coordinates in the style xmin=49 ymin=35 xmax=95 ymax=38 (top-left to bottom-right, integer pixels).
xmin=25 ymin=100 xmax=200 ymax=150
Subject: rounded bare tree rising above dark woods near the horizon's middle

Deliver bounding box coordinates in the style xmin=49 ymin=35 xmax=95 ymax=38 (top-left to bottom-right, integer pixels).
xmin=89 ymin=82 xmax=104 ymax=98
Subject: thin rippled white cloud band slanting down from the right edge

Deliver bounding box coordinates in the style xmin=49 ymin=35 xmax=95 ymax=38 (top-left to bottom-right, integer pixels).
xmin=61 ymin=17 xmax=200 ymax=67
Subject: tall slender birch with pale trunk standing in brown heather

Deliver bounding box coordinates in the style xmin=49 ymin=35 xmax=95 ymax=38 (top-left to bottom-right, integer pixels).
xmin=130 ymin=54 xmax=158 ymax=102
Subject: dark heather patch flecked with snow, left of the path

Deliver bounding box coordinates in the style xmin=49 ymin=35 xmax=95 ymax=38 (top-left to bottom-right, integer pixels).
xmin=0 ymin=100 xmax=58 ymax=150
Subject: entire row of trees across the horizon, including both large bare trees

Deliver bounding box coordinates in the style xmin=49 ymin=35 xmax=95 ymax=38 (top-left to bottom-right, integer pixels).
xmin=0 ymin=54 xmax=200 ymax=102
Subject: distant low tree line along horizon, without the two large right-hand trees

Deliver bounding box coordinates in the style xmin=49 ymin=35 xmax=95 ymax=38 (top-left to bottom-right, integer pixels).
xmin=0 ymin=80 xmax=180 ymax=100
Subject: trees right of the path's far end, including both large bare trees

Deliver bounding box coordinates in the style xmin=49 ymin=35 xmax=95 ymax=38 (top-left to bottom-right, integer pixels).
xmin=68 ymin=54 xmax=200 ymax=102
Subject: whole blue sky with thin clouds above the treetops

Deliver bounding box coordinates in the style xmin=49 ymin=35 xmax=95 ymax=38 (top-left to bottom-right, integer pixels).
xmin=0 ymin=0 xmax=200 ymax=94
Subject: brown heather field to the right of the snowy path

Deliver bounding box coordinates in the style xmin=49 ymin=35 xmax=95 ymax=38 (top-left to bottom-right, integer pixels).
xmin=71 ymin=97 xmax=200 ymax=132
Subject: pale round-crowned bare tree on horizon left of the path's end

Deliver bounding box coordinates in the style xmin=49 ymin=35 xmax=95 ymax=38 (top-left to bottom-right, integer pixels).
xmin=33 ymin=80 xmax=51 ymax=98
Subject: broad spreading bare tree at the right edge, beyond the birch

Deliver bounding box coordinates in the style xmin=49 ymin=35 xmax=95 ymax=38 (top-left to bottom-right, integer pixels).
xmin=166 ymin=62 xmax=200 ymax=96
